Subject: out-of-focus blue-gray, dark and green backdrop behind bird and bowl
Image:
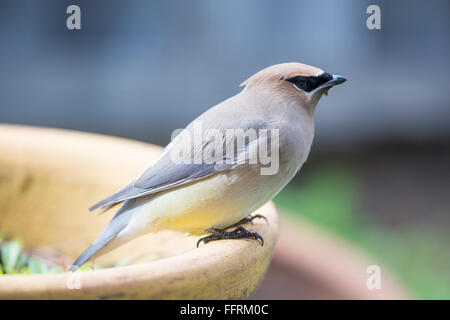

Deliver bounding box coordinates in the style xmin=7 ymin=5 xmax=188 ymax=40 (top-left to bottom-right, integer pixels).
xmin=0 ymin=0 xmax=450 ymax=298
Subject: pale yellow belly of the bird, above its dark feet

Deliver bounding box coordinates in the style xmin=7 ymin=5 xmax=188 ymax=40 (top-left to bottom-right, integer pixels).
xmin=123 ymin=165 xmax=276 ymax=235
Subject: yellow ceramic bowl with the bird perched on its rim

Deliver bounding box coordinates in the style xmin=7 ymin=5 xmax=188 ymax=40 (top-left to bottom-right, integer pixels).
xmin=0 ymin=125 xmax=278 ymax=299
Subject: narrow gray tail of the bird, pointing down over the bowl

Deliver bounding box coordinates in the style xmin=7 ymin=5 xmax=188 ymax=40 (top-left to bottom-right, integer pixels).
xmin=69 ymin=206 xmax=131 ymax=271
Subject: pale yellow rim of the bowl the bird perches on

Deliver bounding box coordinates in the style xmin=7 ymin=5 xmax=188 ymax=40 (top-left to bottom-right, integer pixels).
xmin=0 ymin=124 xmax=279 ymax=299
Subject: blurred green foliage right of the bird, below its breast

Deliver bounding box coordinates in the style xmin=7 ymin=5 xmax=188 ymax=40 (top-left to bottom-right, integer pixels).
xmin=274 ymin=164 xmax=450 ymax=299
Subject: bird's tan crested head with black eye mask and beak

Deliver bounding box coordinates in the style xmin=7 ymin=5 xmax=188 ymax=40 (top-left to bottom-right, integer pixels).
xmin=241 ymin=62 xmax=346 ymax=111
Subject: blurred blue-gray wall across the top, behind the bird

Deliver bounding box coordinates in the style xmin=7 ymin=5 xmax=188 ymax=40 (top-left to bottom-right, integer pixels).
xmin=0 ymin=0 xmax=450 ymax=150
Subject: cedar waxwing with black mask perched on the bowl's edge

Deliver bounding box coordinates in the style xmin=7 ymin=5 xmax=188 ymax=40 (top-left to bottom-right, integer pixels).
xmin=70 ymin=63 xmax=346 ymax=271
